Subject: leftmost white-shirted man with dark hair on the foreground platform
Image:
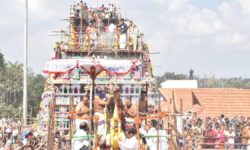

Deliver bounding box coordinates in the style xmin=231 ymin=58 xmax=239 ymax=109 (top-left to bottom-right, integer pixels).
xmin=72 ymin=122 xmax=89 ymax=150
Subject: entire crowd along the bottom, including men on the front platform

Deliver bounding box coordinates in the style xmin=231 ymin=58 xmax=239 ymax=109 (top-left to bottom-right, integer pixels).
xmin=0 ymin=96 xmax=250 ymax=150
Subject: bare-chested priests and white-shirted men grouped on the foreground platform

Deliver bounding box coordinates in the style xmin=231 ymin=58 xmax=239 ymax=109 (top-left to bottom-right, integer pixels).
xmin=72 ymin=87 xmax=168 ymax=150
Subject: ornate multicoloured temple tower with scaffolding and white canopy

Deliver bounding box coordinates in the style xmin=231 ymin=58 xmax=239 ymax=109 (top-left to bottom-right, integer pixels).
xmin=36 ymin=1 xmax=164 ymax=149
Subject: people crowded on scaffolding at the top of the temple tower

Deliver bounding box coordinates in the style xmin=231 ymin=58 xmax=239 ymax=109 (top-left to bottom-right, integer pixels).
xmin=54 ymin=1 xmax=147 ymax=59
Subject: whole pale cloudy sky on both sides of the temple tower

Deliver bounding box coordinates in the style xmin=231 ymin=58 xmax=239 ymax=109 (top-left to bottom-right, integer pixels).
xmin=0 ymin=0 xmax=250 ymax=78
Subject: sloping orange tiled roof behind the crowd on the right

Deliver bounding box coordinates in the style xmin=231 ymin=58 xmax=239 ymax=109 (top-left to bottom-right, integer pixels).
xmin=160 ymin=88 xmax=250 ymax=116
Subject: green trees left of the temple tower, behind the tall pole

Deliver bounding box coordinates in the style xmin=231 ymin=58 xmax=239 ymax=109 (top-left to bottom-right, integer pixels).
xmin=0 ymin=53 xmax=45 ymax=116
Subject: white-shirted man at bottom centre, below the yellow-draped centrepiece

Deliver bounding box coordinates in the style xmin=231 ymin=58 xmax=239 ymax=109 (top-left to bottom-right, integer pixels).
xmin=119 ymin=128 xmax=139 ymax=150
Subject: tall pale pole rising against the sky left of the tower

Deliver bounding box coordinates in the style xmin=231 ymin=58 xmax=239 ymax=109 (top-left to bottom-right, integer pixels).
xmin=23 ymin=0 xmax=28 ymax=126
